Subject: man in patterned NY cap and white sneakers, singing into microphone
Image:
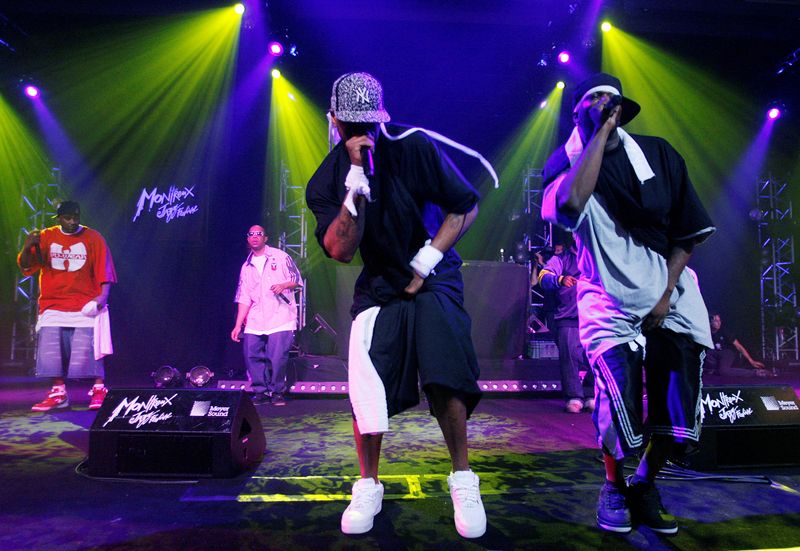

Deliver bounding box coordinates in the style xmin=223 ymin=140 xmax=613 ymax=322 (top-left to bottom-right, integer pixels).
xmin=306 ymin=73 xmax=486 ymax=538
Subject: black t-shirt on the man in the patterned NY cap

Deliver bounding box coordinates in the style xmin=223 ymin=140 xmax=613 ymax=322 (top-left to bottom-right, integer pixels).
xmin=306 ymin=125 xmax=479 ymax=316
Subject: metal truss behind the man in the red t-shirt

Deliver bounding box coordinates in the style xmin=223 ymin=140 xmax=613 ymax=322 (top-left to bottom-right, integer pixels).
xmin=9 ymin=168 xmax=62 ymax=362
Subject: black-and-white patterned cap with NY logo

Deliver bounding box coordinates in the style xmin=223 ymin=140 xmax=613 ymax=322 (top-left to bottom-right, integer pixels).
xmin=331 ymin=73 xmax=391 ymax=122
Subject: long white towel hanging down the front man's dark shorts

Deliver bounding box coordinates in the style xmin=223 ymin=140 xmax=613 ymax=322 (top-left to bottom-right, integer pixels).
xmin=347 ymin=306 xmax=389 ymax=434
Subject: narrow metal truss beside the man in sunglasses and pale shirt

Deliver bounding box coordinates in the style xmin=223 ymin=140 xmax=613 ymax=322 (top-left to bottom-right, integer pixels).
xmin=278 ymin=162 xmax=308 ymax=330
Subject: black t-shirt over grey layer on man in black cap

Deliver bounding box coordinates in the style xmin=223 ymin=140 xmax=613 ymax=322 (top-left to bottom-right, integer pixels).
xmin=544 ymin=135 xmax=713 ymax=257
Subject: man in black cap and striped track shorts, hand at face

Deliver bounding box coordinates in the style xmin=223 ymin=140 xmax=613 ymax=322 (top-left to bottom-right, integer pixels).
xmin=542 ymin=73 xmax=715 ymax=534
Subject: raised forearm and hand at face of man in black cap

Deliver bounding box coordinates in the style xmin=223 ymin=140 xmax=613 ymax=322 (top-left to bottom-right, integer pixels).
xmin=556 ymin=101 xmax=621 ymax=217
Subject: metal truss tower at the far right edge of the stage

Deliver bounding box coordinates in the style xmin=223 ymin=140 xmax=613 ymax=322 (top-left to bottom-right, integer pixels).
xmin=755 ymin=177 xmax=798 ymax=360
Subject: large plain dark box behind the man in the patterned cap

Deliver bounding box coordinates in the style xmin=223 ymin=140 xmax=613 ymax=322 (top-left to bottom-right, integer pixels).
xmin=336 ymin=260 xmax=530 ymax=359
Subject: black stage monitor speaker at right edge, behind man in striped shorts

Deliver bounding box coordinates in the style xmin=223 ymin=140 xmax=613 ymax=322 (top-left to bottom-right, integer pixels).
xmin=680 ymin=385 xmax=800 ymax=470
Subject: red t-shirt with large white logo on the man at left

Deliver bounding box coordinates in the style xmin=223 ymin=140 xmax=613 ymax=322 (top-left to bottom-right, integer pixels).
xmin=17 ymin=226 xmax=117 ymax=314
